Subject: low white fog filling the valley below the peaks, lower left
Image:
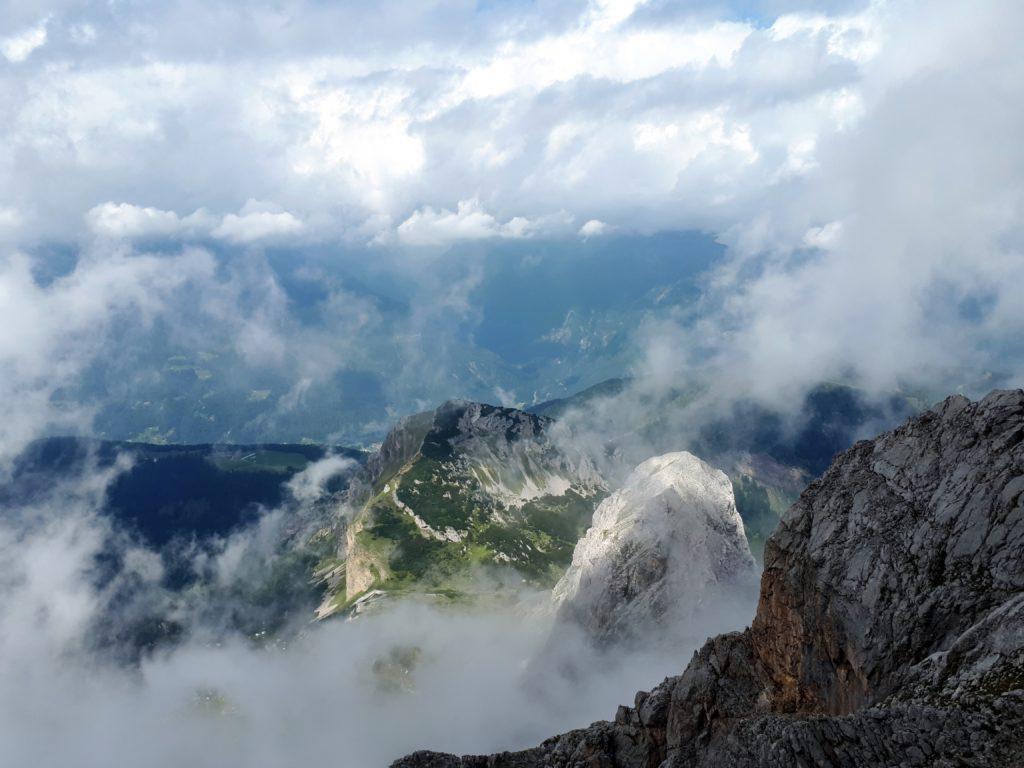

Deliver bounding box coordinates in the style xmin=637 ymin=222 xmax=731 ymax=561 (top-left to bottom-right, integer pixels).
xmin=0 ymin=460 xmax=751 ymax=768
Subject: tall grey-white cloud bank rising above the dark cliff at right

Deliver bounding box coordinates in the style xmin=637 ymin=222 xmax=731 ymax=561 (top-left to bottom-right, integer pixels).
xmin=687 ymin=3 xmax=1024 ymax=402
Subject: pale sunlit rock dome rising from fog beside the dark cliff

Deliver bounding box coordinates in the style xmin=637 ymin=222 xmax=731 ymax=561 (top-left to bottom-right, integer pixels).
xmin=553 ymin=453 xmax=755 ymax=647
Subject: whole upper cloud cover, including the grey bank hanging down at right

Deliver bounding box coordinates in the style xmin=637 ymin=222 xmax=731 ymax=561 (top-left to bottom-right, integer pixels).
xmin=0 ymin=0 xmax=1024 ymax=409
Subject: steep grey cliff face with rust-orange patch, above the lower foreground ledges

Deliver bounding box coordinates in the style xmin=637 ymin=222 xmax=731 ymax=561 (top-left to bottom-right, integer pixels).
xmin=752 ymin=392 xmax=1024 ymax=714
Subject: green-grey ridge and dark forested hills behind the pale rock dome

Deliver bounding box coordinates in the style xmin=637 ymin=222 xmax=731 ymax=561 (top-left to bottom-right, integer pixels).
xmin=0 ymin=379 xmax=914 ymax=647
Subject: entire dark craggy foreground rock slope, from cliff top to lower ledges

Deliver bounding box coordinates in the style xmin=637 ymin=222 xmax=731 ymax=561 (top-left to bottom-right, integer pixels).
xmin=396 ymin=390 xmax=1024 ymax=768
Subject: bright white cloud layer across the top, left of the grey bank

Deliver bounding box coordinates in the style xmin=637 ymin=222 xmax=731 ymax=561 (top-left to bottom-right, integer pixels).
xmin=0 ymin=3 xmax=887 ymax=243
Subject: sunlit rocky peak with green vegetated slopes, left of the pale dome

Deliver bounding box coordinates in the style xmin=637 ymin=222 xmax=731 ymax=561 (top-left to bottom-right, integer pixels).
xmin=318 ymin=400 xmax=605 ymax=617
